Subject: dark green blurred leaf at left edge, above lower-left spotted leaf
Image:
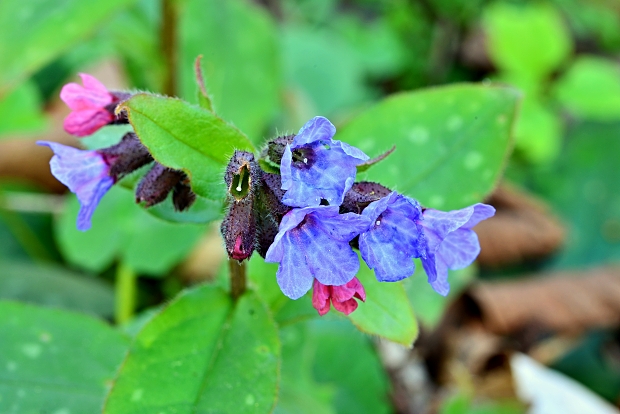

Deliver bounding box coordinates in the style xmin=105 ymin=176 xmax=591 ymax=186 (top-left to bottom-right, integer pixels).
xmin=0 ymin=261 xmax=114 ymax=316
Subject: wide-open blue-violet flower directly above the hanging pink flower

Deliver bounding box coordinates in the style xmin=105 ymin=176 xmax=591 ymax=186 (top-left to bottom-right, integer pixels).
xmin=265 ymin=206 xmax=370 ymax=299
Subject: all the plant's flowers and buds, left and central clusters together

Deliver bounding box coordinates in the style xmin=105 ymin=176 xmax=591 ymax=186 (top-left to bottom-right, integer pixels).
xmin=39 ymin=74 xmax=495 ymax=315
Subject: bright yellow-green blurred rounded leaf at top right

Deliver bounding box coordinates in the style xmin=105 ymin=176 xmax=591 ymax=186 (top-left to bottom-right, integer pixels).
xmin=484 ymin=2 xmax=572 ymax=79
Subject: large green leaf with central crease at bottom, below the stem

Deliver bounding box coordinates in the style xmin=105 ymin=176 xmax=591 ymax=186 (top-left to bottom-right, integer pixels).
xmin=104 ymin=286 xmax=280 ymax=414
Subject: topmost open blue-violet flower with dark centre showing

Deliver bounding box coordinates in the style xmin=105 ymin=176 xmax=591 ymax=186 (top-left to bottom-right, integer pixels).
xmin=280 ymin=116 xmax=368 ymax=207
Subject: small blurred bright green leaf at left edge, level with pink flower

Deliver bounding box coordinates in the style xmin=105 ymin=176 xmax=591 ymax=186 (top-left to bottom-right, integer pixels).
xmin=0 ymin=81 xmax=47 ymax=137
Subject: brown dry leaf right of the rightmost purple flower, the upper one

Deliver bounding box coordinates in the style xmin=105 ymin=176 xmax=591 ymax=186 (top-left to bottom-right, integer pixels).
xmin=475 ymin=183 xmax=566 ymax=267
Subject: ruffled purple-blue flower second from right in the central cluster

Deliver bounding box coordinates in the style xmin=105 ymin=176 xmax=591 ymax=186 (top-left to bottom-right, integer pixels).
xmin=359 ymin=192 xmax=425 ymax=282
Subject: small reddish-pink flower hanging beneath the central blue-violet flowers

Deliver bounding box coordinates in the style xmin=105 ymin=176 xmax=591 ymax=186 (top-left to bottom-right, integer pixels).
xmin=312 ymin=277 xmax=366 ymax=316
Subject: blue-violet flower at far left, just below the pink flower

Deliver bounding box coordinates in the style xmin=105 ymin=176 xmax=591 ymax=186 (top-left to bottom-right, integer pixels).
xmin=37 ymin=141 xmax=114 ymax=231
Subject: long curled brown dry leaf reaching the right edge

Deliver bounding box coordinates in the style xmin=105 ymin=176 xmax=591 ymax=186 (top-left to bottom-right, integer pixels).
xmin=465 ymin=267 xmax=620 ymax=335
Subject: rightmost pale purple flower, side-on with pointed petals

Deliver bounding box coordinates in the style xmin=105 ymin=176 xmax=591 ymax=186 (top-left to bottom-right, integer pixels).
xmin=418 ymin=203 xmax=495 ymax=296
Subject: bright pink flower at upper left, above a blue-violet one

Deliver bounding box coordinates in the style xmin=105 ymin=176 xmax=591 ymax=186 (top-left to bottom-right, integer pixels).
xmin=60 ymin=73 xmax=118 ymax=137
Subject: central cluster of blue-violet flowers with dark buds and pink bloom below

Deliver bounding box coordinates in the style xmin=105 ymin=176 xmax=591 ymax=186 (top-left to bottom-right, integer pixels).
xmin=222 ymin=117 xmax=495 ymax=315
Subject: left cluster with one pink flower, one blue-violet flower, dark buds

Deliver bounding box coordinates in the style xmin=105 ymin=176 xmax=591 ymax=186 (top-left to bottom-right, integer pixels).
xmin=37 ymin=73 xmax=196 ymax=231
